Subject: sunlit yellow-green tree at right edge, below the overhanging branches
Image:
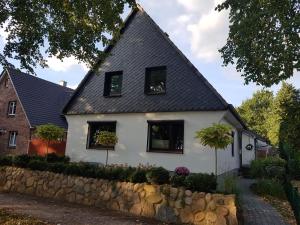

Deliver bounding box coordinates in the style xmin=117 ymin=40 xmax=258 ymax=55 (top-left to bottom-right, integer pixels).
xmin=267 ymin=83 xmax=300 ymax=151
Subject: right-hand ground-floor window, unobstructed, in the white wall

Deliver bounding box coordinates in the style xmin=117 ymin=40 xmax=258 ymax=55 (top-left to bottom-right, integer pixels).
xmin=147 ymin=120 xmax=184 ymax=153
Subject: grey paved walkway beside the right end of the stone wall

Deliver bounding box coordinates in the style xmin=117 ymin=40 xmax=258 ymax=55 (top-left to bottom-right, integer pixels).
xmin=238 ymin=178 xmax=287 ymax=225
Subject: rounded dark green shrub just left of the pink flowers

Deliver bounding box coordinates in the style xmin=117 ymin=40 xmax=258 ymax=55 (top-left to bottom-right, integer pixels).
xmin=146 ymin=167 xmax=170 ymax=184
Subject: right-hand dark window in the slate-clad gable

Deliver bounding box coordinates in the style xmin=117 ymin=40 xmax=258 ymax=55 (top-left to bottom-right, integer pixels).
xmin=145 ymin=66 xmax=167 ymax=95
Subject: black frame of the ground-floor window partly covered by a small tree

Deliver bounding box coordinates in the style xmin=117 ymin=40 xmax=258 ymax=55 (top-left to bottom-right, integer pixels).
xmin=86 ymin=121 xmax=117 ymax=151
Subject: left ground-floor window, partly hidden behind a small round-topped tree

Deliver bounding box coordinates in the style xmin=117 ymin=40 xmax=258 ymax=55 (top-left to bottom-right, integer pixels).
xmin=87 ymin=121 xmax=116 ymax=150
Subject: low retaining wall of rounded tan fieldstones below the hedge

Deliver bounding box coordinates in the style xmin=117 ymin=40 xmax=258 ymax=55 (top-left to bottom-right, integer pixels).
xmin=0 ymin=167 xmax=237 ymax=225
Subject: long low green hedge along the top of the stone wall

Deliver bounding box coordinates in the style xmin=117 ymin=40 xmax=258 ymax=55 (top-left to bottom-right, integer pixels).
xmin=0 ymin=154 xmax=217 ymax=192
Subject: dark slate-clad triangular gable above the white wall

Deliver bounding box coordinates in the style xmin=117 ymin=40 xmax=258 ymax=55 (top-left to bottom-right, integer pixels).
xmin=64 ymin=7 xmax=229 ymax=114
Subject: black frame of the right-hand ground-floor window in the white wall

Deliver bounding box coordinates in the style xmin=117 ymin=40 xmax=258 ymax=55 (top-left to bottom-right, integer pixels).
xmin=147 ymin=120 xmax=184 ymax=154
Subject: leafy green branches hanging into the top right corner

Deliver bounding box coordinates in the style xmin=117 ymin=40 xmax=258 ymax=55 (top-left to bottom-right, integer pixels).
xmin=216 ymin=0 xmax=300 ymax=87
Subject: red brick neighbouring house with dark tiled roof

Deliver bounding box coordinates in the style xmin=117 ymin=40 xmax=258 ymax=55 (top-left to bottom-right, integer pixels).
xmin=0 ymin=68 xmax=73 ymax=155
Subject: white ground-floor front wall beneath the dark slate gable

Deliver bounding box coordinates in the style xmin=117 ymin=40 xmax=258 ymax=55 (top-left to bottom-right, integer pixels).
xmin=66 ymin=112 xmax=238 ymax=173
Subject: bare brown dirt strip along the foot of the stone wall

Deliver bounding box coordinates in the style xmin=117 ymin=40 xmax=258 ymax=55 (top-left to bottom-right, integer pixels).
xmin=0 ymin=193 xmax=168 ymax=225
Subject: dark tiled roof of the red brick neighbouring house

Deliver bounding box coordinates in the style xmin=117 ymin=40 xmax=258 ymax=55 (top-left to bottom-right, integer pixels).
xmin=6 ymin=68 xmax=73 ymax=128
